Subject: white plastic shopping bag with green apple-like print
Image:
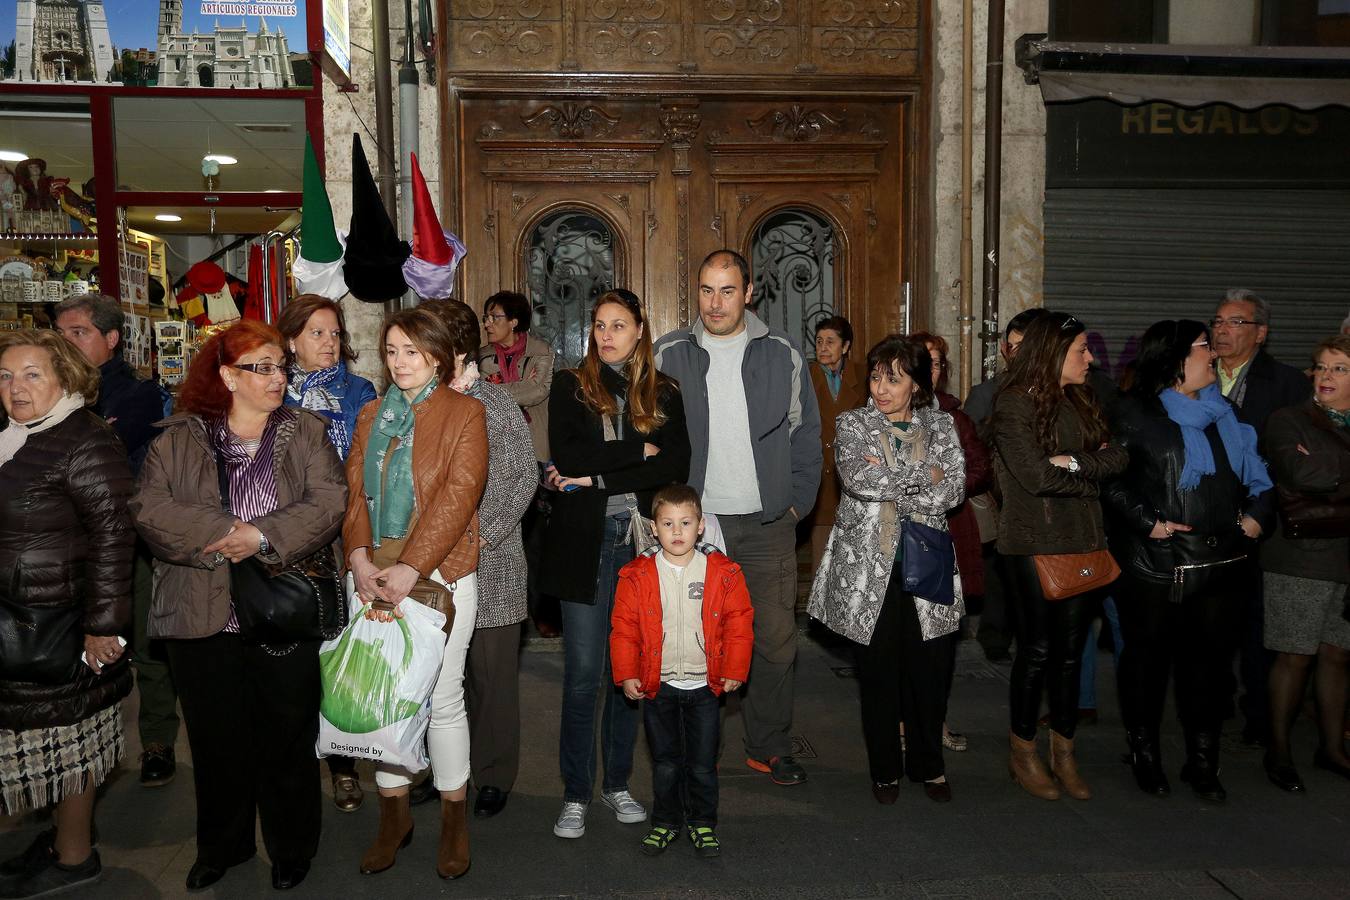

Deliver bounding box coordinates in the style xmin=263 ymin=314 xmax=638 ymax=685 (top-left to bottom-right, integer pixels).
xmin=316 ymin=575 xmax=446 ymax=772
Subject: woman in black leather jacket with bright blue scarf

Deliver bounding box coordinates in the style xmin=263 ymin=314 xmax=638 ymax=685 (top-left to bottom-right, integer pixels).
xmin=1107 ymin=320 xmax=1272 ymax=801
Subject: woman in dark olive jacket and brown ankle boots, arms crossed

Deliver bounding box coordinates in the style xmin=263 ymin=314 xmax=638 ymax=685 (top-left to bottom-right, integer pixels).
xmin=991 ymin=312 xmax=1127 ymax=800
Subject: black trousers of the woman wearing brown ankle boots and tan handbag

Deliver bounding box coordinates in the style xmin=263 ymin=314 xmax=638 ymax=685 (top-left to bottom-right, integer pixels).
xmin=1003 ymin=556 xmax=1096 ymax=741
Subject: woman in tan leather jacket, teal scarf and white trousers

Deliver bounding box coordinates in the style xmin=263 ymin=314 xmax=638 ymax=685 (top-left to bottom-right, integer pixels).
xmin=342 ymin=308 xmax=487 ymax=878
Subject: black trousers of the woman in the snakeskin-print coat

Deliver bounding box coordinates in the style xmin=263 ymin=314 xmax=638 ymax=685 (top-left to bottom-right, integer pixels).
xmin=857 ymin=563 xmax=956 ymax=784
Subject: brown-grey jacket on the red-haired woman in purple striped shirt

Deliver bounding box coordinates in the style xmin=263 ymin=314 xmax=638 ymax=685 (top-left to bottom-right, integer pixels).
xmin=128 ymin=407 xmax=347 ymax=638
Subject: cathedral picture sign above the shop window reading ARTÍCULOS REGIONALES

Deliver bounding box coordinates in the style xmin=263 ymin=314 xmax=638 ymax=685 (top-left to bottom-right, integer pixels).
xmin=0 ymin=0 xmax=310 ymax=89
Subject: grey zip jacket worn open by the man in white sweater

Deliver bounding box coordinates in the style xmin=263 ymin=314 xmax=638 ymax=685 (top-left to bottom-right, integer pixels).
xmin=656 ymin=310 xmax=822 ymax=524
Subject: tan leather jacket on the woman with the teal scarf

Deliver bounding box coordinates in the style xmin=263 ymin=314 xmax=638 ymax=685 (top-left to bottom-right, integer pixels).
xmin=342 ymin=385 xmax=487 ymax=582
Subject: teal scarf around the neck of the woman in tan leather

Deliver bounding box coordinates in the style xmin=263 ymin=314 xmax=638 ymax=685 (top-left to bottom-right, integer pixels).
xmin=362 ymin=375 xmax=439 ymax=546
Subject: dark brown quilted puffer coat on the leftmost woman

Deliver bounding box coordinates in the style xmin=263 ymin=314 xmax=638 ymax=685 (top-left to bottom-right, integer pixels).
xmin=0 ymin=409 xmax=135 ymax=731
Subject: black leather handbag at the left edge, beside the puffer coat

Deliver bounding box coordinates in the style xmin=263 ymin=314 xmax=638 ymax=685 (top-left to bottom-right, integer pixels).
xmin=0 ymin=565 xmax=84 ymax=684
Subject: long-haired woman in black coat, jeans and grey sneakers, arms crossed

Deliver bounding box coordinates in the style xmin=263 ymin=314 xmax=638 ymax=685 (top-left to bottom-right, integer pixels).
xmin=540 ymin=290 xmax=689 ymax=838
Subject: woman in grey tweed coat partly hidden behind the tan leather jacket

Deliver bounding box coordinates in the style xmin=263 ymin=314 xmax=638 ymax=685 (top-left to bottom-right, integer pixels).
xmin=425 ymin=300 xmax=539 ymax=819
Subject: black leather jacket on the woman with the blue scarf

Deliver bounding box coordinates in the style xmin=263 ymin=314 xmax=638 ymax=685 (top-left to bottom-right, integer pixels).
xmin=1103 ymin=397 xmax=1274 ymax=580
